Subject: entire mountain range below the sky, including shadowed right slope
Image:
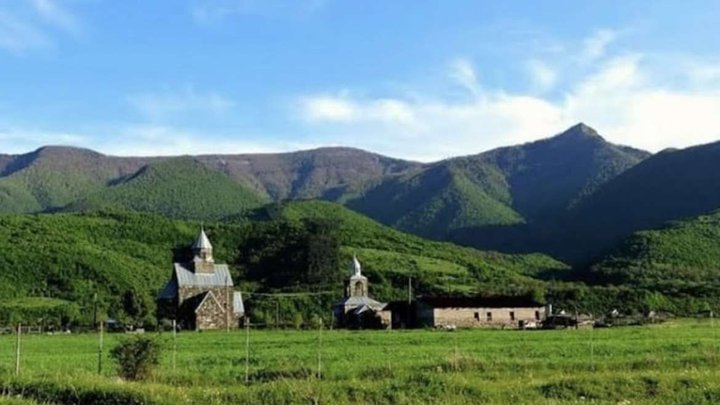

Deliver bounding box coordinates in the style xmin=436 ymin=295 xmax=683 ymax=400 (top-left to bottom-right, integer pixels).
xmin=0 ymin=124 xmax=720 ymax=264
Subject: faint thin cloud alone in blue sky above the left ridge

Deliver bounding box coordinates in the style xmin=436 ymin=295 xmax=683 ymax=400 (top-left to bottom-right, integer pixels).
xmin=127 ymin=86 xmax=235 ymax=120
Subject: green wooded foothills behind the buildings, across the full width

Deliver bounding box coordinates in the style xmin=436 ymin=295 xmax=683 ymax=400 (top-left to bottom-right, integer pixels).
xmin=0 ymin=201 xmax=720 ymax=327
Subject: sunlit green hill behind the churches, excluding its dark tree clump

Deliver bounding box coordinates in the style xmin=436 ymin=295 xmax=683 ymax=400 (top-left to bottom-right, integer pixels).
xmin=0 ymin=201 xmax=566 ymax=322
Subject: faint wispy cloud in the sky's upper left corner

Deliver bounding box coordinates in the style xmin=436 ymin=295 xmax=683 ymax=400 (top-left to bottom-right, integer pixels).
xmin=0 ymin=0 xmax=80 ymax=54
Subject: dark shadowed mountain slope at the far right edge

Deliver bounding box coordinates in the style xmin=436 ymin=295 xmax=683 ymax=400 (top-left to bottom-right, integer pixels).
xmin=566 ymin=143 xmax=720 ymax=258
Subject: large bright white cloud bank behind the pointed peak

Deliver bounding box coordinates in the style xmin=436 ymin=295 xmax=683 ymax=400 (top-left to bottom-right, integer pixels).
xmin=299 ymin=54 xmax=720 ymax=161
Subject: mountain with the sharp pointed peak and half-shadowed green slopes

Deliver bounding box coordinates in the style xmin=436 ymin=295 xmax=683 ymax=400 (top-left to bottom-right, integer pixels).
xmin=348 ymin=124 xmax=649 ymax=241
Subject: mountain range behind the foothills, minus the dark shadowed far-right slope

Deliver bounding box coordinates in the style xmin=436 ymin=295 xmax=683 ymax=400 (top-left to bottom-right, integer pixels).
xmin=0 ymin=124 xmax=648 ymax=264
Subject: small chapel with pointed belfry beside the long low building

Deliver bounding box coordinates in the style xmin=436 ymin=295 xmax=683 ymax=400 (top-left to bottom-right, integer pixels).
xmin=334 ymin=256 xmax=391 ymax=329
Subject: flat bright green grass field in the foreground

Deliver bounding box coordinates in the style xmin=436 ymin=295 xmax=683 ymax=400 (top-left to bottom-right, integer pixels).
xmin=0 ymin=320 xmax=720 ymax=404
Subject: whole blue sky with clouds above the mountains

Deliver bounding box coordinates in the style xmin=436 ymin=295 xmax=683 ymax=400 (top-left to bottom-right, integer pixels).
xmin=0 ymin=0 xmax=720 ymax=161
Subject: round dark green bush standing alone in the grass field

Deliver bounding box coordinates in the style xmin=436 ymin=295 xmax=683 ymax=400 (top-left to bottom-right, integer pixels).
xmin=110 ymin=335 xmax=160 ymax=380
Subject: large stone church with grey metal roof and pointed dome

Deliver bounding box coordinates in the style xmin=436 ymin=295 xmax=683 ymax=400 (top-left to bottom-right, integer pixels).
xmin=157 ymin=229 xmax=245 ymax=330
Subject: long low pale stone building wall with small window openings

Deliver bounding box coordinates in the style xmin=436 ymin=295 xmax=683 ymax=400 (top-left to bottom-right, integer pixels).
xmin=418 ymin=307 xmax=545 ymax=328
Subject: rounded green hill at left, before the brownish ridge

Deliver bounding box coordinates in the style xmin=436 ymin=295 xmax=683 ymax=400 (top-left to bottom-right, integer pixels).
xmin=67 ymin=157 xmax=264 ymax=220
